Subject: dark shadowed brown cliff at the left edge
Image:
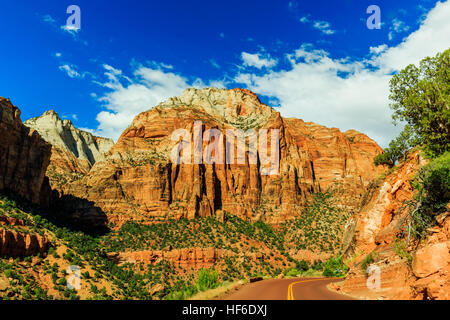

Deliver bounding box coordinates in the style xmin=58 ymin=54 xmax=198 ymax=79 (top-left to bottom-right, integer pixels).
xmin=0 ymin=98 xmax=51 ymax=205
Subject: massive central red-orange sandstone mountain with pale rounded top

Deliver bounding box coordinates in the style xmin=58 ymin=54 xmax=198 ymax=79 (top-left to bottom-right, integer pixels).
xmin=64 ymin=88 xmax=382 ymax=224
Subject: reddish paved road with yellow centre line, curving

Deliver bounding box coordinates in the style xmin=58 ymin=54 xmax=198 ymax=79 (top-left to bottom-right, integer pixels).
xmin=224 ymin=278 xmax=352 ymax=300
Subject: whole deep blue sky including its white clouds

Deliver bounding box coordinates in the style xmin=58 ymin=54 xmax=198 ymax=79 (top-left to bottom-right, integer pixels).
xmin=0 ymin=0 xmax=450 ymax=146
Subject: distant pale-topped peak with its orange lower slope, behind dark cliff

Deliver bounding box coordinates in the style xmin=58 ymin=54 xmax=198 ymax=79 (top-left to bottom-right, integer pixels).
xmin=24 ymin=110 xmax=114 ymax=191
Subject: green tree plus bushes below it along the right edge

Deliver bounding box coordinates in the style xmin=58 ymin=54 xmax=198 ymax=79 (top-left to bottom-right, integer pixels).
xmin=374 ymin=49 xmax=450 ymax=240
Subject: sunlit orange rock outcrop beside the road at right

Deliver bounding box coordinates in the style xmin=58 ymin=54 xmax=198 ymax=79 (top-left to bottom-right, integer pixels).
xmin=335 ymin=152 xmax=450 ymax=299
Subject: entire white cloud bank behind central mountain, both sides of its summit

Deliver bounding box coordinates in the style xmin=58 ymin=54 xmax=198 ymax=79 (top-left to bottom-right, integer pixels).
xmin=84 ymin=2 xmax=450 ymax=147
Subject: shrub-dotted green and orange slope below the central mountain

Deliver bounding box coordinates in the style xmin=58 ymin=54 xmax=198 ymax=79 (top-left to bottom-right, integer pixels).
xmin=0 ymin=184 xmax=352 ymax=300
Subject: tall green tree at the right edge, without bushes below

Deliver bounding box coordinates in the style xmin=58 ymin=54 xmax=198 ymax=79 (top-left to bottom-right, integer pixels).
xmin=389 ymin=49 xmax=450 ymax=157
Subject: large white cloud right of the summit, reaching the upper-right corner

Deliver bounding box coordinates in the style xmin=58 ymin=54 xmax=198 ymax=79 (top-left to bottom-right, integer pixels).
xmin=235 ymin=2 xmax=450 ymax=146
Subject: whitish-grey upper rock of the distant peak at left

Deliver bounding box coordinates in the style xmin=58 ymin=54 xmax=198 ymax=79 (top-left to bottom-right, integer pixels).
xmin=24 ymin=110 xmax=114 ymax=165
